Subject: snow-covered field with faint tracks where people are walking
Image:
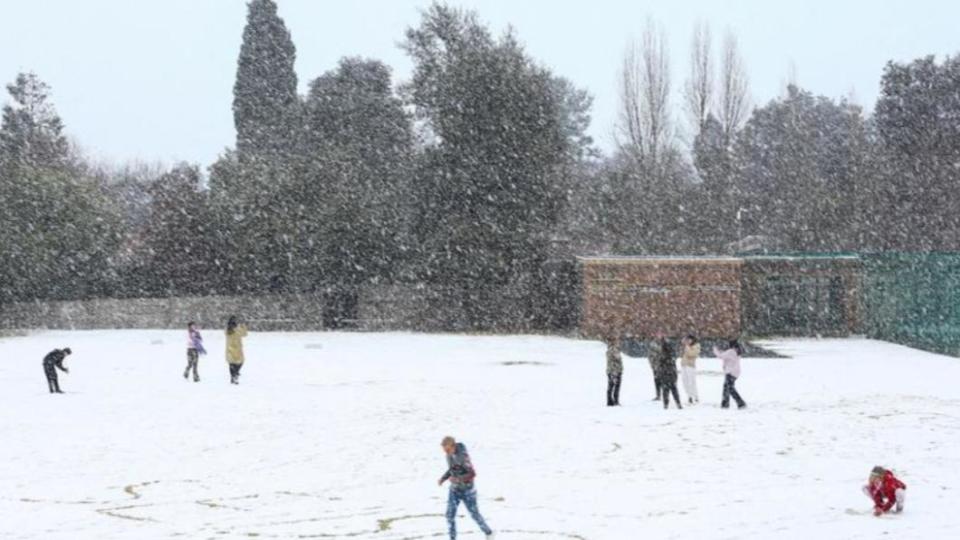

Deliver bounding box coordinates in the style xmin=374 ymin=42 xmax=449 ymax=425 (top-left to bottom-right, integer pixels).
xmin=0 ymin=331 xmax=960 ymax=540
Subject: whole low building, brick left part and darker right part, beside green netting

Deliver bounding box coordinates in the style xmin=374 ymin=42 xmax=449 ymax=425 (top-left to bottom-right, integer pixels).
xmin=580 ymin=255 xmax=863 ymax=337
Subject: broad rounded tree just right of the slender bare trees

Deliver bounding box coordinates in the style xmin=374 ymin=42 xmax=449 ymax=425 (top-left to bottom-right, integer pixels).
xmin=735 ymin=85 xmax=865 ymax=252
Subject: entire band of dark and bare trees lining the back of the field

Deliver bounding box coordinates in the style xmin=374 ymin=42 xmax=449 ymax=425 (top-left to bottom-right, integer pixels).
xmin=0 ymin=4 xmax=960 ymax=334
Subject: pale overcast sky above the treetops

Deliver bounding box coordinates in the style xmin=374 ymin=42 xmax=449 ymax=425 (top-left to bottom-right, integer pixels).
xmin=0 ymin=0 xmax=960 ymax=165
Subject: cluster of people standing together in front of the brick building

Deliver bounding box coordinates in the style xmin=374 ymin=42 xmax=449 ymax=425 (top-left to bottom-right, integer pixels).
xmin=605 ymin=332 xmax=747 ymax=409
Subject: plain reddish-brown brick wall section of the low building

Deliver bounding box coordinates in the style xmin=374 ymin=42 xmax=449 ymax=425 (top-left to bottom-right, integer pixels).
xmin=580 ymin=257 xmax=743 ymax=337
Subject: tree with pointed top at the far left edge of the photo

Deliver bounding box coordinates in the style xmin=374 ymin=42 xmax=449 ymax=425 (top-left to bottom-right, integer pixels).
xmin=0 ymin=74 xmax=119 ymax=302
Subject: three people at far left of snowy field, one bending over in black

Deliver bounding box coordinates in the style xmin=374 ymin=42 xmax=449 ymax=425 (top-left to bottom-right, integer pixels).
xmin=43 ymin=316 xmax=247 ymax=394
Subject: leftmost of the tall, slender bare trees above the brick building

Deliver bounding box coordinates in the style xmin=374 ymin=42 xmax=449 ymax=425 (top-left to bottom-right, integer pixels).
xmin=619 ymin=19 xmax=672 ymax=167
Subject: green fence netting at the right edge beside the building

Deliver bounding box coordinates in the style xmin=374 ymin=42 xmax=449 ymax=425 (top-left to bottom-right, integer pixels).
xmin=861 ymin=253 xmax=960 ymax=355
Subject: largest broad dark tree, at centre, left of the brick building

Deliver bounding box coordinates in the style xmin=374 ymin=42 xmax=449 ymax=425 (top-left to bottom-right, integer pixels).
xmin=405 ymin=4 xmax=584 ymax=327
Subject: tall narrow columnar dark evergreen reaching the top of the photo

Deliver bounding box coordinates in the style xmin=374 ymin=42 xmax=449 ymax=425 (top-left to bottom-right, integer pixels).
xmin=218 ymin=0 xmax=302 ymax=291
